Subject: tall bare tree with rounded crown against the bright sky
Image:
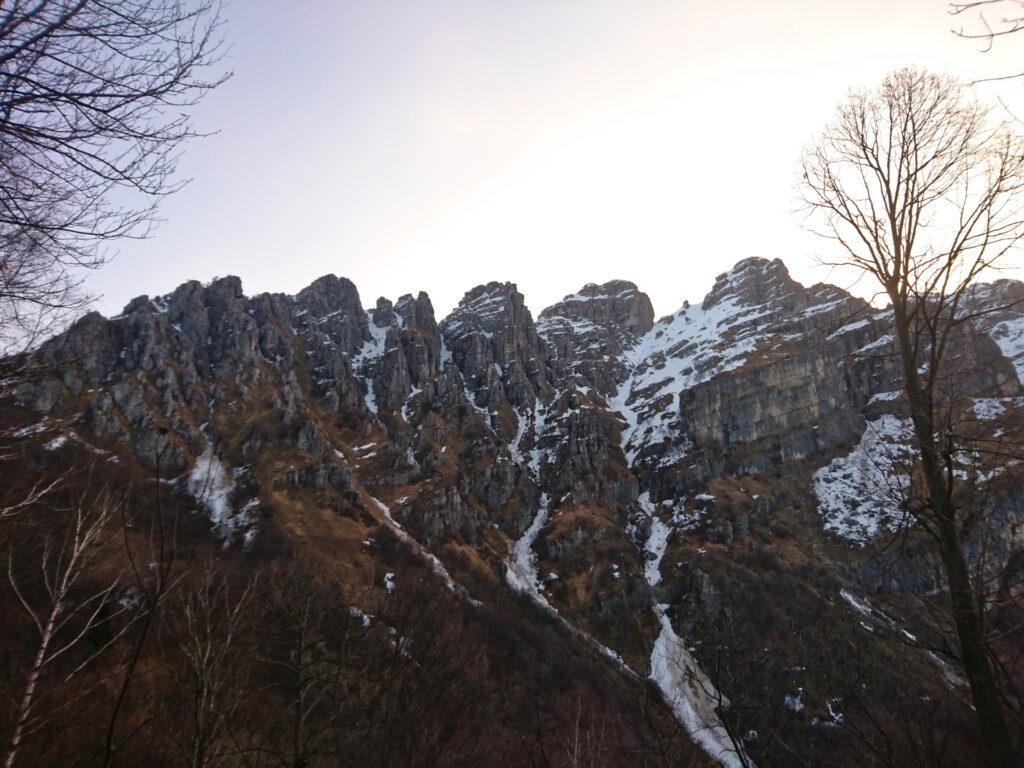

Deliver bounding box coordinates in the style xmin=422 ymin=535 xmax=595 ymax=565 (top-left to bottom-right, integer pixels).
xmin=802 ymin=70 xmax=1024 ymax=765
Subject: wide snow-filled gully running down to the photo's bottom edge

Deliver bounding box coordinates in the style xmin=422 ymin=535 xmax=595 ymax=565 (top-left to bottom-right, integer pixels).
xmin=639 ymin=493 xmax=753 ymax=768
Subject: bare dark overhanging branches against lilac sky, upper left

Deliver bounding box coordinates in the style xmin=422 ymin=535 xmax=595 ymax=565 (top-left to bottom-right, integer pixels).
xmin=0 ymin=0 xmax=226 ymax=351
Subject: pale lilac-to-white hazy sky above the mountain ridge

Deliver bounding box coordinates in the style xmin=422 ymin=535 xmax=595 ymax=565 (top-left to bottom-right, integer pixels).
xmin=88 ymin=0 xmax=1024 ymax=319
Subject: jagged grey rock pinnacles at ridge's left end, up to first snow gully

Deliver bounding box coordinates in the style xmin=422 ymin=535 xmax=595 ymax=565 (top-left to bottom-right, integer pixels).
xmin=16 ymin=275 xmax=380 ymax=470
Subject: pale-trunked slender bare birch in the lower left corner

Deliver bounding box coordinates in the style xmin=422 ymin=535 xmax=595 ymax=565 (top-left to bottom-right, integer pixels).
xmin=4 ymin=488 xmax=123 ymax=768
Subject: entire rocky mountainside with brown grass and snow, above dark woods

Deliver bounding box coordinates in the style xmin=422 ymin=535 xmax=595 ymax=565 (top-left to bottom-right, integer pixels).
xmin=12 ymin=258 xmax=1024 ymax=764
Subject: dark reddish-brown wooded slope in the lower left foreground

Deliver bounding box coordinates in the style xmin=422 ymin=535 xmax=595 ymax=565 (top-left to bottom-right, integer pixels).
xmin=0 ymin=447 xmax=706 ymax=767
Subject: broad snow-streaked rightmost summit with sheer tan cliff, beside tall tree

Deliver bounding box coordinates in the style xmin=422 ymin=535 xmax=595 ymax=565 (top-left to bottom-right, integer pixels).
xmin=614 ymin=259 xmax=894 ymax=474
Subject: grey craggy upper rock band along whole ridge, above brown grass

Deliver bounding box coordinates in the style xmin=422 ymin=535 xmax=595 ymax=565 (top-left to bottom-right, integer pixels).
xmin=14 ymin=258 xmax=1024 ymax=524
